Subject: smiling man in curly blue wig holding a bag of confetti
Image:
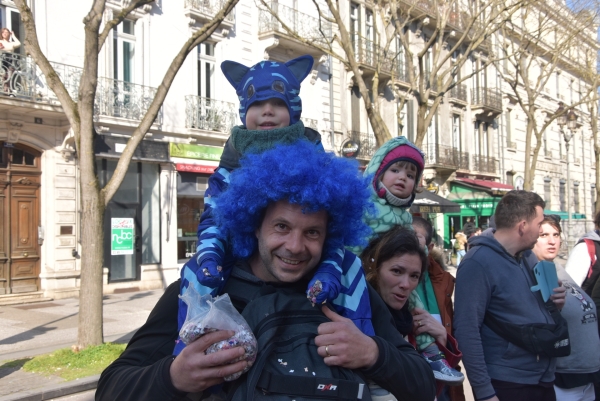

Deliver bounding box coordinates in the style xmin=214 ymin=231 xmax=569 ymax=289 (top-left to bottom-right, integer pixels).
xmin=96 ymin=144 xmax=435 ymax=401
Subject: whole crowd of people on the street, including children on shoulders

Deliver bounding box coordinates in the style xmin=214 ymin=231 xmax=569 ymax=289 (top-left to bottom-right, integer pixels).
xmin=96 ymin=56 xmax=600 ymax=401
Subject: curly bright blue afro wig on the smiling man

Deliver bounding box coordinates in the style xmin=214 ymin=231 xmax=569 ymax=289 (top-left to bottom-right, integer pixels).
xmin=214 ymin=140 xmax=374 ymax=258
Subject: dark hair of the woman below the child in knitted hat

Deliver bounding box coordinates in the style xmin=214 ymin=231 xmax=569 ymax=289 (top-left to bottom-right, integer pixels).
xmin=360 ymin=226 xmax=427 ymax=291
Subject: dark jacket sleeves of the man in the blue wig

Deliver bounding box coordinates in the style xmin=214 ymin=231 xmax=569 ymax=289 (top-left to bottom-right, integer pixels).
xmin=96 ymin=262 xmax=435 ymax=401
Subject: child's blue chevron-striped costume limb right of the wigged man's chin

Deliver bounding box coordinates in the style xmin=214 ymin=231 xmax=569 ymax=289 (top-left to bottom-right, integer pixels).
xmin=307 ymin=248 xmax=375 ymax=336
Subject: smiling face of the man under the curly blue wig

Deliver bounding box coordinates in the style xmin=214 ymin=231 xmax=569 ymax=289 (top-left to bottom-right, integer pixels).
xmin=250 ymin=201 xmax=327 ymax=283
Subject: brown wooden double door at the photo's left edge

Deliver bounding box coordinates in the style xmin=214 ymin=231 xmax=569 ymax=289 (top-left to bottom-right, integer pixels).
xmin=0 ymin=142 xmax=41 ymax=295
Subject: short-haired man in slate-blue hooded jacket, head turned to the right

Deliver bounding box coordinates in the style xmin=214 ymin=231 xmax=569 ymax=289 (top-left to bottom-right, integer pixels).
xmin=454 ymin=191 xmax=565 ymax=401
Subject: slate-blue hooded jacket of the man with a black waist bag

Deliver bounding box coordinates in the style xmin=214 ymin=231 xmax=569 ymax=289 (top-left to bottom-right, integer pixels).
xmin=454 ymin=230 xmax=556 ymax=399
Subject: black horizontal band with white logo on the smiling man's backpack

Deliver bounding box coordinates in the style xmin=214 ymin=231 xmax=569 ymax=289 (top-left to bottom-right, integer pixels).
xmin=256 ymin=370 xmax=365 ymax=400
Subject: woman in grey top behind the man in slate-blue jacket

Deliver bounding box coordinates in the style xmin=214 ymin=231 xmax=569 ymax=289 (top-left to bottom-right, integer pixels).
xmin=533 ymin=215 xmax=600 ymax=401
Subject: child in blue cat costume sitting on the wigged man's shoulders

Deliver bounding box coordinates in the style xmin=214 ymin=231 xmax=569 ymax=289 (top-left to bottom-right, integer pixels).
xmin=174 ymin=55 xmax=373 ymax=355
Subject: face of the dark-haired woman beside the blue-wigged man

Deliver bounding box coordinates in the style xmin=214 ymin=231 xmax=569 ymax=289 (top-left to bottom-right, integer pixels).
xmin=377 ymin=254 xmax=421 ymax=310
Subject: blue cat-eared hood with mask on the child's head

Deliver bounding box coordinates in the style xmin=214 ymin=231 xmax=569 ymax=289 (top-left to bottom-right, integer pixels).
xmin=221 ymin=55 xmax=314 ymax=125
